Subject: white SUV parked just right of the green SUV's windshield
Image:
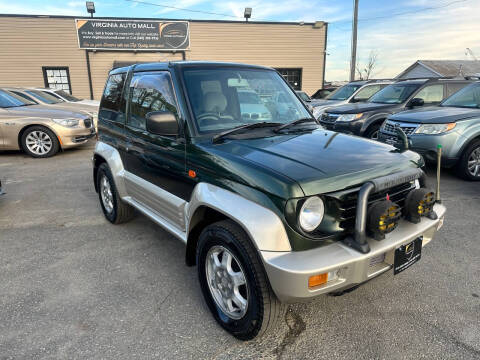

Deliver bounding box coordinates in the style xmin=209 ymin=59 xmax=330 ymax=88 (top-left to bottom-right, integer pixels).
xmin=311 ymin=80 xmax=393 ymax=119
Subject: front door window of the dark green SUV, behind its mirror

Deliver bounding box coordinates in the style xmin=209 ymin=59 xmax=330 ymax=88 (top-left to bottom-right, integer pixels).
xmin=127 ymin=72 xmax=177 ymax=130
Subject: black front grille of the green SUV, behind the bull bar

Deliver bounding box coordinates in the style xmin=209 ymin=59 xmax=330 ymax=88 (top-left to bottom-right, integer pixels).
xmin=327 ymin=182 xmax=415 ymax=234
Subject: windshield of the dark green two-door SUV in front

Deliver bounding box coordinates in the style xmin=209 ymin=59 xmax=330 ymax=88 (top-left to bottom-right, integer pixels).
xmin=183 ymin=68 xmax=311 ymax=133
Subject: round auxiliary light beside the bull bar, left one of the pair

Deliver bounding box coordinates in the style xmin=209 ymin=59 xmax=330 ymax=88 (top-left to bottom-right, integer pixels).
xmin=367 ymin=200 xmax=401 ymax=240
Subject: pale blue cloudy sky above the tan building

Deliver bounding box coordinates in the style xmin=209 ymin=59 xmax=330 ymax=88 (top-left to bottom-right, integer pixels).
xmin=0 ymin=0 xmax=480 ymax=81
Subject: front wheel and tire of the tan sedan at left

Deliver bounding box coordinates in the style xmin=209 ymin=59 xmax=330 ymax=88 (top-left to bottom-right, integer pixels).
xmin=20 ymin=126 xmax=60 ymax=158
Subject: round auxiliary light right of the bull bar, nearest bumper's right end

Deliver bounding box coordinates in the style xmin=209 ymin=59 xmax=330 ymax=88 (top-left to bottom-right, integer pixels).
xmin=405 ymin=188 xmax=437 ymax=224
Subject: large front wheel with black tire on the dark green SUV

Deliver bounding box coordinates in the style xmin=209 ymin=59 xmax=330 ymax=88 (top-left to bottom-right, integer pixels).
xmin=197 ymin=220 xmax=286 ymax=340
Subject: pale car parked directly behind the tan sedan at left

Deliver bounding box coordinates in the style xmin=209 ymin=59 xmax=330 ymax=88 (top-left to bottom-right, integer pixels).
xmin=5 ymin=88 xmax=98 ymax=126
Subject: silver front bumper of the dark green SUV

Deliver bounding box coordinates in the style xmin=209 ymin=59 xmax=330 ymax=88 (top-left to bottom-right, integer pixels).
xmin=260 ymin=204 xmax=445 ymax=302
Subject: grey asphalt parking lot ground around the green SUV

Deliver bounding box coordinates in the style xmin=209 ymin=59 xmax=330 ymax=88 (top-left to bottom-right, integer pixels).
xmin=0 ymin=143 xmax=480 ymax=360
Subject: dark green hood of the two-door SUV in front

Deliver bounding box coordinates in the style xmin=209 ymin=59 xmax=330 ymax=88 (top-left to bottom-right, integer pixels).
xmin=209 ymin=129 xmax=423 ymax=195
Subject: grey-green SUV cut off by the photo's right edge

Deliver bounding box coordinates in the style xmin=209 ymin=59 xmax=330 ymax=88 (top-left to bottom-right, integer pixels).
xmin=379 ymin=82 xmax=480 ymax=181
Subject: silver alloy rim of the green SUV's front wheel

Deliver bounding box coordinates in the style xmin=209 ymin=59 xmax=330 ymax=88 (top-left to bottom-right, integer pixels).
xmin=205 ymin=245 xmax=249 ymax=320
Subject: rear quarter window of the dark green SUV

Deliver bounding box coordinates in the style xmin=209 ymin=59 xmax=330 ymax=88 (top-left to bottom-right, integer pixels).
xmin=98 ymin=73 xmax=126 ymax=123
